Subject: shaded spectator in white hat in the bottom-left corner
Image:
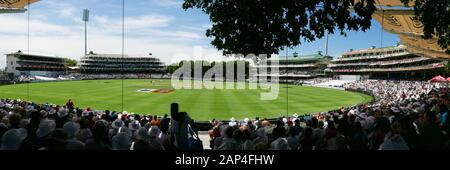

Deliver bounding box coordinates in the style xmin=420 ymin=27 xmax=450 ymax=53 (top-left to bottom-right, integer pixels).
xmin=0 ymin=128 xmax=27 ymax=150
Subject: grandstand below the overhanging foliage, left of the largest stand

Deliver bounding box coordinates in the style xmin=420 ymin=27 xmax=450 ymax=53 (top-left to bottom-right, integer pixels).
xmin=252 ymin=52 xmax=332 ymax=83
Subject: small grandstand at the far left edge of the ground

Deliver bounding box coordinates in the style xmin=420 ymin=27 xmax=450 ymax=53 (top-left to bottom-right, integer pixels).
xmin=5 ymin=50 xmax=67 ymax=77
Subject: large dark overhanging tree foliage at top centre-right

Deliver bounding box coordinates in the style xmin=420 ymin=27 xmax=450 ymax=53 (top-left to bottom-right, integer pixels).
xmin=183 ymin=0 xmax=376 ymax=55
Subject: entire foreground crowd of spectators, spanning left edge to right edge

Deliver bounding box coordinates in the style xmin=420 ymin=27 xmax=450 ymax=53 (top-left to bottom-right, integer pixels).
xmin=0 ymin=80 xmax=450 ymax=150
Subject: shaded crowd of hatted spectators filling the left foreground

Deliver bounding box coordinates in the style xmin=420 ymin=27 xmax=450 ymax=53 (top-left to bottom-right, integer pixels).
xmin=0 ymin=99 xmax=198 ymax=150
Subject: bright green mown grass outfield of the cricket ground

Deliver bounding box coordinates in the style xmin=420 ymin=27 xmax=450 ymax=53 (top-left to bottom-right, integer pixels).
xmin=0 ymin=80 xmax=372 ymax=120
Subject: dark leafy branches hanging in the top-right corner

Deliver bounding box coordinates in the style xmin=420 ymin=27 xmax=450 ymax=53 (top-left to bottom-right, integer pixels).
xmin=401 ymin=0 xmax=450 ymax=54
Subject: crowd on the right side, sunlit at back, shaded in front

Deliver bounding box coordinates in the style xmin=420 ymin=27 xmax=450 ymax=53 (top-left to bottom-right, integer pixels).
xmin=209 ymin=80 xmax=450 ymax=150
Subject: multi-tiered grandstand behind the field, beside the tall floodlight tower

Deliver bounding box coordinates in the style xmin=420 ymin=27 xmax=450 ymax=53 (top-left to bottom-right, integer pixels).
xmin=79 ymin=51 xmax=166 ymax=78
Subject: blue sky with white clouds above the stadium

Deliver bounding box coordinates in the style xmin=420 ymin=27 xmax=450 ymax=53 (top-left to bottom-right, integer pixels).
xmin=0 ymin=0 xmax=399 ymax=68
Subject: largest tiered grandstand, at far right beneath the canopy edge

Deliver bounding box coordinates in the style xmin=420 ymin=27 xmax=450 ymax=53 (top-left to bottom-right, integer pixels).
xmin=325 ymin=45 xmax=445 ymax=79
